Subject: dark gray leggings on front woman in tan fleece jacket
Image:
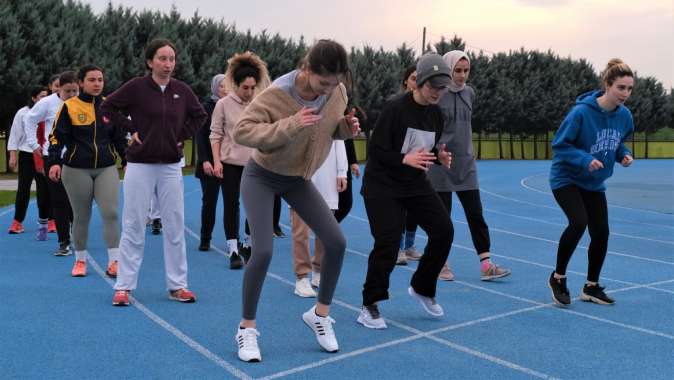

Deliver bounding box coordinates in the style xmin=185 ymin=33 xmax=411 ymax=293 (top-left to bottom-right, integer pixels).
xmin=241 ymin=159 xmax=346 ymax=320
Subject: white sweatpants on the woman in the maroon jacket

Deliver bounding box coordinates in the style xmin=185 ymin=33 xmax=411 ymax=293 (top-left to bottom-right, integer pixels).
xmin=115 ymin=163 xmax=187 ymax=290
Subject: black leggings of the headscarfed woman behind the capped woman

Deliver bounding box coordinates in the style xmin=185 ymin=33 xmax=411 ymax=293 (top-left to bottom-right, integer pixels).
xmin=438 ymin=190 xmax=491 ymax=255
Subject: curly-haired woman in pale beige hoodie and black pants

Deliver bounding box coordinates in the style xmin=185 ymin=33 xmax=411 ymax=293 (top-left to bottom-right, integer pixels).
xmin=210 ymin=51 xmax=270 ymax=269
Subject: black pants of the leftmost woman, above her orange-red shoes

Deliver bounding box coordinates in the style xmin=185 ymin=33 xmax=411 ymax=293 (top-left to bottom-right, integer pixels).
xmin=14 ymin=151 xmax=51 ymax=223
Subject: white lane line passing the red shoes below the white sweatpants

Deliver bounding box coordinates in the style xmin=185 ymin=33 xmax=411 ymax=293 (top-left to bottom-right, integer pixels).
xmin=87 ymin=254 xmax=252 ymax=380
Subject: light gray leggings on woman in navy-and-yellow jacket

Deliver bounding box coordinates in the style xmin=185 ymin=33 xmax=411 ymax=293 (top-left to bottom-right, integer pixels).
xmin=61 ymin=165 xmax=119 ymax=251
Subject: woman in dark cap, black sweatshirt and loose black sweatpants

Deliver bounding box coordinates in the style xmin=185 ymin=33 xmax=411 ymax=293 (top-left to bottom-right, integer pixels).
xmin=358 ymin=54 xmax=454 ymax=329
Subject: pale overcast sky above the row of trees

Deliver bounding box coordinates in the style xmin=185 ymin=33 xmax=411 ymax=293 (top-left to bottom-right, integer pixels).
xmin=83 ymin=0 xmax=674 ymax=88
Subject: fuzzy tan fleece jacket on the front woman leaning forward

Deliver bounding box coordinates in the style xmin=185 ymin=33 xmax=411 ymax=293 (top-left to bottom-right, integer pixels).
xmin=234 ymin=83 xmax=352 ymax=180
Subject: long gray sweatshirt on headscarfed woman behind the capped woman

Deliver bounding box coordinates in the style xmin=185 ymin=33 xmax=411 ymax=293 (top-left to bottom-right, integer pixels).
xmin=428 ymin=86 xmax=479 ymax=192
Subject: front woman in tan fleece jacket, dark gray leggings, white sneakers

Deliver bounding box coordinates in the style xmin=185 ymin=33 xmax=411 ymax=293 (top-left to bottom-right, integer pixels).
xmin=234 ymin=40 xmax=359 ymax=362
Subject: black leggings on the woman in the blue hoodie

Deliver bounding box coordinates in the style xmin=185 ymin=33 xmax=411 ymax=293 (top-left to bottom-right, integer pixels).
xmin=552 ymin=185 xmax=609 ymax=282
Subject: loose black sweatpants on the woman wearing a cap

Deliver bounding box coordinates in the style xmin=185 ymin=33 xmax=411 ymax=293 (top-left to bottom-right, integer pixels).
xmin=363 ymin=193 xmax=454 ymax=305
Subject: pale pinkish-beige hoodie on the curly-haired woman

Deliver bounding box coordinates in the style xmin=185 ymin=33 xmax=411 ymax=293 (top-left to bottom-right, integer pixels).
xmin=209 ymin=92 xmax=254 ymax=166
